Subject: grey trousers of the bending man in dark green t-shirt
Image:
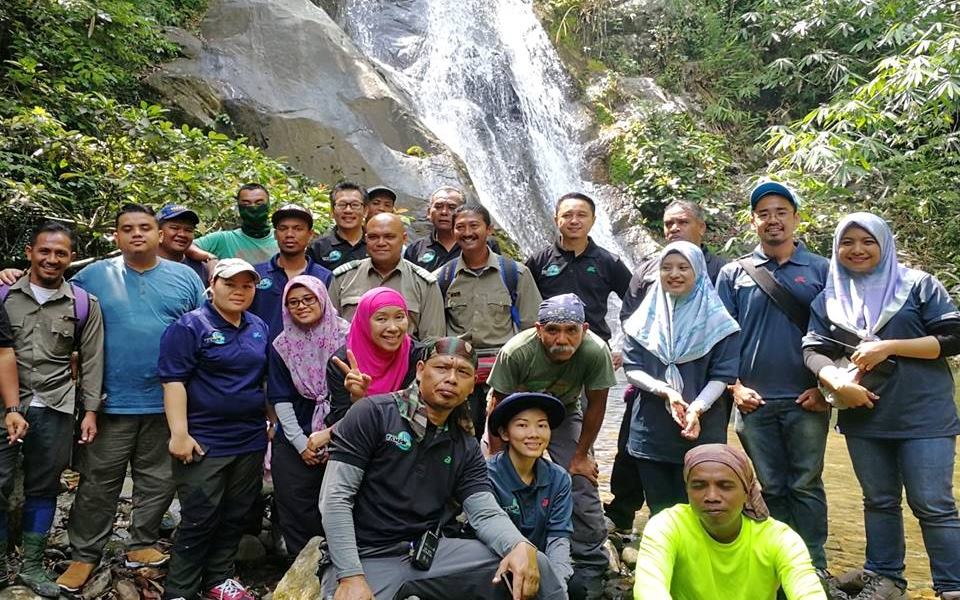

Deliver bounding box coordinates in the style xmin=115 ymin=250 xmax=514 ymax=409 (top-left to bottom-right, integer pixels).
xmin=547 ymin=409 xmax=609 ymax=579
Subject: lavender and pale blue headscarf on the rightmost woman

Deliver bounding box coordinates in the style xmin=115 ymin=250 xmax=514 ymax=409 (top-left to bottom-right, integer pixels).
xmin=823 ymin=212 xmax=919 ymax=340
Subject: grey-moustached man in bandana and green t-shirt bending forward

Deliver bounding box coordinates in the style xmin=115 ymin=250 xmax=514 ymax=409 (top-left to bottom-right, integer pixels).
xmin=487 ymin=294 xmax=616 ymax=599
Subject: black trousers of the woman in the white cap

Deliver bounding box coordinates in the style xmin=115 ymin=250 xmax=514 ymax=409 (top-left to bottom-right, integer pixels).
xmin=164 ymin=451 xmax=264 ymax=598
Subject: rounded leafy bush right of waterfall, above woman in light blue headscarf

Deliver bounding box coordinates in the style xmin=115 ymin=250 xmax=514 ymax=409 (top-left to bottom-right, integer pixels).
xmin=609 ymin=111 xmax=733 ymax=224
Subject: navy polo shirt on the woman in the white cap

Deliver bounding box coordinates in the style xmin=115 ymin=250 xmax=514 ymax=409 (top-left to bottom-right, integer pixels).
xmin=157 ymin=301 xmax=268 ymax=457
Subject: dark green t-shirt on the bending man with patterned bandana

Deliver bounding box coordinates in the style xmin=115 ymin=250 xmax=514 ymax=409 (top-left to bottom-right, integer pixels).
xmin=487 ymin=327 xmax=617 ymax=408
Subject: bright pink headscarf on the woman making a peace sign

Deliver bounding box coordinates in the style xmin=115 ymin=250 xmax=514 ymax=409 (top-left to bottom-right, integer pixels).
xmin=347 ymin=287 xmax=413 ymax=395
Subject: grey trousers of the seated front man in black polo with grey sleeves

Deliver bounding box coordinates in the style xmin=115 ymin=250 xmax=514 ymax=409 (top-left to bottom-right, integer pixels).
xmin=320 ymin=538 xmax=567 ymax=600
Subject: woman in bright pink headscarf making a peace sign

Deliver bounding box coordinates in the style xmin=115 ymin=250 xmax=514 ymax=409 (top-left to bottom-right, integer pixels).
xmin=327 ymin=287 xmax=423 ymax=424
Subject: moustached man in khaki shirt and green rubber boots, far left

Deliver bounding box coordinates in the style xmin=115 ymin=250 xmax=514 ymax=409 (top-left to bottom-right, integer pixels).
xmin=0 ymin=221 xmax=103 ymax=598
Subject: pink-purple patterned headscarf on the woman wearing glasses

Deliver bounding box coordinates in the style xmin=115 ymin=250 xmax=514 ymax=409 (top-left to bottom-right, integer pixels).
xmin=273 ymin=275 xmax=349 ymax=431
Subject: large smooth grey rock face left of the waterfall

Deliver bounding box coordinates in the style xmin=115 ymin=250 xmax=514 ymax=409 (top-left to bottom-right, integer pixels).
xmin=146 ymin=0 xmax=470 ymax=212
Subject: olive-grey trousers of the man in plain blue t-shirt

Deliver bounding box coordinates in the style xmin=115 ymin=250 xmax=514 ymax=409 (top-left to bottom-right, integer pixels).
xmin=67 ymin=413 xmax=174 ymax=563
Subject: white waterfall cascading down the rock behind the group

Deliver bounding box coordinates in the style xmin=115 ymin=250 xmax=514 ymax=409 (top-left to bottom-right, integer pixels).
xmin=341 ymin=0 xmax=628 ymax=260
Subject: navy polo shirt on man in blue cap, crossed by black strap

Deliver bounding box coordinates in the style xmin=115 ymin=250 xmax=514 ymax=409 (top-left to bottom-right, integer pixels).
xmin=717 ymin=243 xmax=830 ymax=400
